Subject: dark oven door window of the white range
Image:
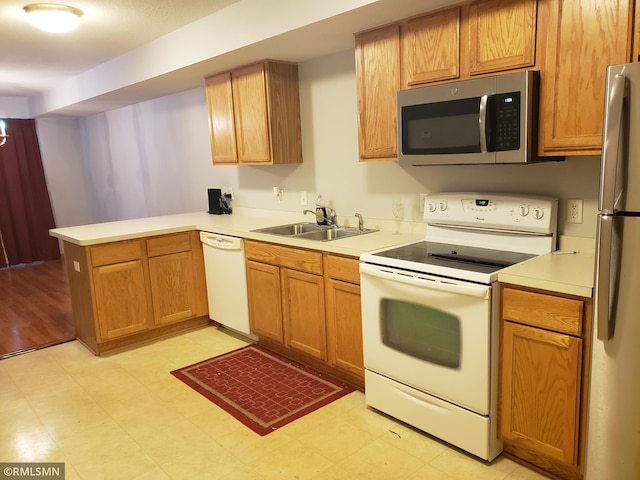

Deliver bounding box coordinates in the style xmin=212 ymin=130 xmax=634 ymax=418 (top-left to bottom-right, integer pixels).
xmin=380 ymin=298 xmax=462 ymax=368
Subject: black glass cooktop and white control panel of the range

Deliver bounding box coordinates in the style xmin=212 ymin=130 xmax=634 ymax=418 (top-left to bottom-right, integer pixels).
xmin=360 ymin=192 xmax=558 ymax=284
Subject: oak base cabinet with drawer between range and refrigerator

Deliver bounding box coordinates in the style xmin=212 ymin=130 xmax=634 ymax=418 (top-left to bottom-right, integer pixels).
xmin=499 ymin=285 xmax=591 ymax=479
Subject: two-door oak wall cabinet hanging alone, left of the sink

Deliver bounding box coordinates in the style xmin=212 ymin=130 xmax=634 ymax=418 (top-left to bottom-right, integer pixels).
xmin=206 ymin=60 xmax=302 ymax=165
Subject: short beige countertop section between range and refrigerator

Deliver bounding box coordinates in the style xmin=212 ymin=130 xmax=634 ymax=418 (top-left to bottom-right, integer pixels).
xmin=498 ymin=238 xmax=595 ymax=298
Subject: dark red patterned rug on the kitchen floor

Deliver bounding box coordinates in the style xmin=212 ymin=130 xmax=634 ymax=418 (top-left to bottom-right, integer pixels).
xmin=171 ymin=345 xmax=354 ymax=435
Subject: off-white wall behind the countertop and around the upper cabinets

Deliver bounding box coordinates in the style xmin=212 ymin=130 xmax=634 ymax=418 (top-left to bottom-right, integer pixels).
xmin=39 ymin=50 xmax=599 ymax=237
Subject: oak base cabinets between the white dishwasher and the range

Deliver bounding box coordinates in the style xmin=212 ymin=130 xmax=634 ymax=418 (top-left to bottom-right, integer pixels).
xmin=245 ymin=240 xmax=364 ymax=388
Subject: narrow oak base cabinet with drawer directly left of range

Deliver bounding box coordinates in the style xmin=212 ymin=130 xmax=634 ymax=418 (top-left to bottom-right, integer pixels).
xmin=324 ymin=254 xmax=364 ymax=379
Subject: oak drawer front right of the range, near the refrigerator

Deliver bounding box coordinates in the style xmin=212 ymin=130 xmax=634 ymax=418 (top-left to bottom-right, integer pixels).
xmin=502 ymin=287 xmax=584 ymax=336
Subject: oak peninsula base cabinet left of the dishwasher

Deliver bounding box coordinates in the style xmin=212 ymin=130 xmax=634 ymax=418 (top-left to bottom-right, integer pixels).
xmin=64 ymin=232 xmax=208 ymax=355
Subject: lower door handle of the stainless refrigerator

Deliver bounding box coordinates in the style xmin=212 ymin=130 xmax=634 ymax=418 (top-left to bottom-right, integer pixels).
xmin=593 ymin=215 xmax=613 ymax=341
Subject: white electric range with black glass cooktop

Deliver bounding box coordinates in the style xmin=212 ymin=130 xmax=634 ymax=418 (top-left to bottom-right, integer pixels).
xmin=360 ymin=192 xmax=558 ymax=461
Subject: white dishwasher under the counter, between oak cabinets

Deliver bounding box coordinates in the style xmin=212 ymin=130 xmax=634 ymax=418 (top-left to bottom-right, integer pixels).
xmin=200 ymin=232 xmax=256 ymax=338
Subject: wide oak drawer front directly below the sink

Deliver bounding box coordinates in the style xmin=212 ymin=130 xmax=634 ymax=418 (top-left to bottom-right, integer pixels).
xmin=245 ymin=240 xmax=322 ymax=275
